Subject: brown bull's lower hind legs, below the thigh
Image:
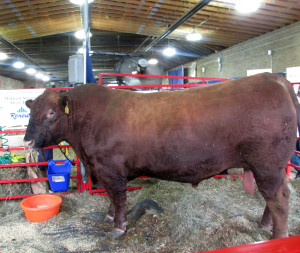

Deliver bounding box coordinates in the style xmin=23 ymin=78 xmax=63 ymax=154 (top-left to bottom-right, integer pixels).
xmin=254 ymin=168 xmax=290 ymax=238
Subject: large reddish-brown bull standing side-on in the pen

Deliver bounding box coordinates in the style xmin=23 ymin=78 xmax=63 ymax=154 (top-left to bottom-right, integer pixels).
xmin=24 ymin=74 xmax=297 ymax=237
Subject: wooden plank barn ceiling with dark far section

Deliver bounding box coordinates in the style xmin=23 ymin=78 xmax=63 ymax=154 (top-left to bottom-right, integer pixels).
xmin=0 ymin=0 xmax=300 ymax=84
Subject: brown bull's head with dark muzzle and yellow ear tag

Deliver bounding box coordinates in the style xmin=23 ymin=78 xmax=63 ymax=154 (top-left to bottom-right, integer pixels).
xmin=24 ymin=89 xmax=71 ymax=149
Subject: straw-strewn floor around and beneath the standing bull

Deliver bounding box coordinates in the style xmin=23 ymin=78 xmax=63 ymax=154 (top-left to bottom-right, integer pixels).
xmin=0 ymin=174 xmax=300 ymax=253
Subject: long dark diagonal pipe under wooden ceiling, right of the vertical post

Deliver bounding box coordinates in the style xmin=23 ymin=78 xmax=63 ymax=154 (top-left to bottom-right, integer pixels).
xmin=143 ymin=0 xmax=211 ymax=52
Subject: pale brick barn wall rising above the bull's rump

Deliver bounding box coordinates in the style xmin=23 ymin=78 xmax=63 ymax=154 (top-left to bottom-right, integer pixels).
xmin=184 ymin=22 xmax=300 ymax=78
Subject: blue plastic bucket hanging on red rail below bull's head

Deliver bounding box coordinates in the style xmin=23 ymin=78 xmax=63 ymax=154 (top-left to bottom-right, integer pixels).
xmin=47 ymin=160 xmax=71 ymax=192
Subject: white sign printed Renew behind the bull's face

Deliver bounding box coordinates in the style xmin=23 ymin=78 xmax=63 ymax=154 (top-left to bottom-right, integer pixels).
xmin=0 ymin=89 xmax=45 ymax=127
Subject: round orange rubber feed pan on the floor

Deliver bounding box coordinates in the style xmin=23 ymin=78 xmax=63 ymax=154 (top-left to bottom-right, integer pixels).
xmin=21 ymin=194 xmax=62 ymax=222
